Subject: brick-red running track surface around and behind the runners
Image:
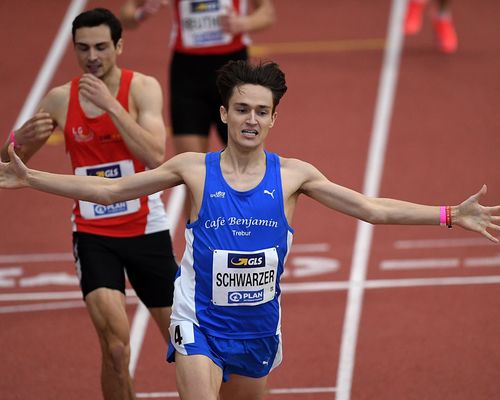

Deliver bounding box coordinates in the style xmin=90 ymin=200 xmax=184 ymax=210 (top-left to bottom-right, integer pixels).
xmin=0 ymin=0 xmax=500 ymax=400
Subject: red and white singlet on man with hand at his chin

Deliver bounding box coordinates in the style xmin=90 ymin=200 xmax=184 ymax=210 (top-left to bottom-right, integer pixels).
xmin=64 ymin=69 xmax=169 ymax=237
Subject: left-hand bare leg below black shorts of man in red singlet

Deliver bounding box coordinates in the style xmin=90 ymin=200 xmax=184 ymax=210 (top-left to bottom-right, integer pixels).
xmin=85 ymin=288 xmax=135 ymax=400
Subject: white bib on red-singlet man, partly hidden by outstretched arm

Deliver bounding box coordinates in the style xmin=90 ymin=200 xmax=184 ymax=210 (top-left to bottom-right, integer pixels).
xmin=75 ymin=160 xmax=141 ymax=219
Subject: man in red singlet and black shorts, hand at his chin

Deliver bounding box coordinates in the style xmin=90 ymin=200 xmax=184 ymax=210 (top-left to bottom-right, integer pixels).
xmin=1 ymin=9 xmax=177 ymax=400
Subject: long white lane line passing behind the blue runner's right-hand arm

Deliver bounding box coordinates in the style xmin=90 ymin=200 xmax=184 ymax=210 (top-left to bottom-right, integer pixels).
xmin=336 ymin=0 xmax=406 ymax=400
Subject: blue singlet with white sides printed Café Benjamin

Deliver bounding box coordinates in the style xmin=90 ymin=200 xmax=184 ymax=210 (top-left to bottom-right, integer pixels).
xmin=172 ymin=152 xmax=293 ymax=339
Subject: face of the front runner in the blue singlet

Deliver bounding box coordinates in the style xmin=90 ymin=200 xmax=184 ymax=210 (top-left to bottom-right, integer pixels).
xmin=221 ymin=84 xmax=276 ymax=147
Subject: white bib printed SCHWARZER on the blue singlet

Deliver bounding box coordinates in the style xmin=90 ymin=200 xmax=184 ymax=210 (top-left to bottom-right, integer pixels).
xmin=212 ymin=247 xmax=278 ymax=306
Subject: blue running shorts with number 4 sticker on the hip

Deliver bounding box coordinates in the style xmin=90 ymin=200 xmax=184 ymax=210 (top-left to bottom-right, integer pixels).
xmin=167 ymin=321 xmax=282 ymax=382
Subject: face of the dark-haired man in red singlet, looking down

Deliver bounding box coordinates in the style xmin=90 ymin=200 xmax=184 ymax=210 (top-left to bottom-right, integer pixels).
xmin=75 ymin=25 xmax=122 ymax=78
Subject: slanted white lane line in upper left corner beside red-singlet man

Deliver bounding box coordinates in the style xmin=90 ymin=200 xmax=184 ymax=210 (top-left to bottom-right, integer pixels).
xmin=10 ymin=0 xmax=87 ymax=129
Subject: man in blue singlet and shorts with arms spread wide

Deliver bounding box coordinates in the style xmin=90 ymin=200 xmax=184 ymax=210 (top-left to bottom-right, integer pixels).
xmin=0 ymin=61 xmax=500 ymax=400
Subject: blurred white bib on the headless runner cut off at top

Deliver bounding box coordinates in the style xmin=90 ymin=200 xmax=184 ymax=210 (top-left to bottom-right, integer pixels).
xmin=179 ymin=0 xmax=233 ymax=48
